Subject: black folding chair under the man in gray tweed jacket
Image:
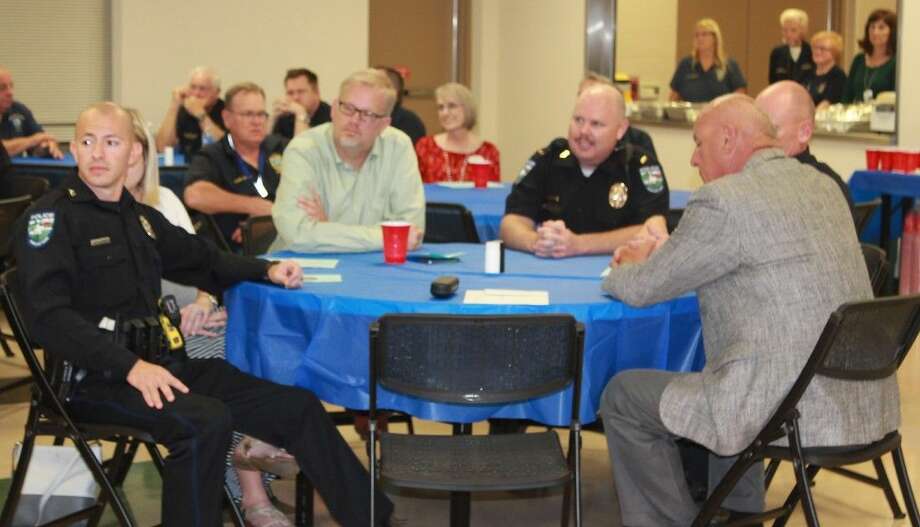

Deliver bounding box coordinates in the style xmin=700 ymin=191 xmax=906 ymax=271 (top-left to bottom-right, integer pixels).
xmin=693 ymin=295 xmax=920 ymax=527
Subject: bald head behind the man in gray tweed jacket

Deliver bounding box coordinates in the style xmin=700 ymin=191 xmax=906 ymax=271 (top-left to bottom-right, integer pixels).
xmin=754 ymin=81 xmax=815 ymax=156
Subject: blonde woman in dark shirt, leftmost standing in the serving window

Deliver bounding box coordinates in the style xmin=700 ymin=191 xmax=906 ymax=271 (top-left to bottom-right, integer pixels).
xmin=670 ymin=18 xmax=747 ymax=102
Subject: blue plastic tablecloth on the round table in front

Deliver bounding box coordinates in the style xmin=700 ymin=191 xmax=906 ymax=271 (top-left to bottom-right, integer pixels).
xmin=225 ymin=244 xmax=704 ymax=425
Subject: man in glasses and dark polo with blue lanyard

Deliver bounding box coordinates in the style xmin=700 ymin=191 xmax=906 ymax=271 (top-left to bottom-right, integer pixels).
xmin=184 ymin=82 xmax=287 ymax=249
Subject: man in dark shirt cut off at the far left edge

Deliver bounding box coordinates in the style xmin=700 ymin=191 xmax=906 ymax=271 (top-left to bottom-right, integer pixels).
xmin=0 ymin=66 xmax=64 ymax=159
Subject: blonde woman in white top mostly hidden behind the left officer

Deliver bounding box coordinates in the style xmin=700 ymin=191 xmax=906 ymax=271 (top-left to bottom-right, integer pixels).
xmin=125 ymin=109 xmax=296 ymax=527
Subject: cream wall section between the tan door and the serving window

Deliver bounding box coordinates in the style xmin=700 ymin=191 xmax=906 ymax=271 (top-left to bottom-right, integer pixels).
xmin=472 ymin=0 xmax=585 ymax=180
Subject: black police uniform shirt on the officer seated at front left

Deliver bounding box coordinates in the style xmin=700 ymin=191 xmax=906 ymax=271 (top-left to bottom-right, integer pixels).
xmin=13 ymin=175 xmax=267 ymax=382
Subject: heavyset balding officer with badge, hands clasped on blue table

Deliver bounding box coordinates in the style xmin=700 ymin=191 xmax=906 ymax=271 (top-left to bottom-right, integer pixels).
xmin=500 ymin=84 xmax=669 ymax=258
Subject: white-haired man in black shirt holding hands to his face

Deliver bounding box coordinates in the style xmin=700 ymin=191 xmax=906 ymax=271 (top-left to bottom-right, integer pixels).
xmin=156 ymin=66 xmax=227 ymax=158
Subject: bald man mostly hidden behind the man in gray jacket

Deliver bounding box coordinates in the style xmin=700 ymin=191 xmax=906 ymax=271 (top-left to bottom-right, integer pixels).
xmin=754 ymin=81 xmax=855 ymax=223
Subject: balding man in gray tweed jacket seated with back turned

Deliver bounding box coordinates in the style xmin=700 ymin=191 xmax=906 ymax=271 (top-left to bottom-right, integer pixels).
xmin=601 ymin=94 xmax=899 ymax=526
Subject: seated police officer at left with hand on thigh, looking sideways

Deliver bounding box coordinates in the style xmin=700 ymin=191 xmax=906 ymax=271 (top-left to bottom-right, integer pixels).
xmin=15 ymin=103 xmax=392 ymax=526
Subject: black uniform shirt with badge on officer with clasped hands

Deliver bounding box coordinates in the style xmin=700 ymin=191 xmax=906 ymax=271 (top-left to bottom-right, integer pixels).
xmin=505 ymin=138 xmax=669 ymax=234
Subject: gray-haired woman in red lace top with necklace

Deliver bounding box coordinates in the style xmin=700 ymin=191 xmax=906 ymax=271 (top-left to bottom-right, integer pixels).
xmin=415 ymin=82 xmax=501 ymax=183
